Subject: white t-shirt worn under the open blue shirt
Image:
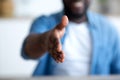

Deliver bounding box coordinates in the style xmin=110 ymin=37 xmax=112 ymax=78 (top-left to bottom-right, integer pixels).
xmin=53 ymin=22 xmax=92 ymax=76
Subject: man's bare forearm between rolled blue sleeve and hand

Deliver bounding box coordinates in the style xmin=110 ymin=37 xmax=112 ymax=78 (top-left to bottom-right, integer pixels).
xmin=24 ymin=32 xmax=49 ymax=59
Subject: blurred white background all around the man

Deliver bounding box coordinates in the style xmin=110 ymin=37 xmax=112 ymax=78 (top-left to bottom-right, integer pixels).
xmin=0 ymin=0 xmax=120 ymax=77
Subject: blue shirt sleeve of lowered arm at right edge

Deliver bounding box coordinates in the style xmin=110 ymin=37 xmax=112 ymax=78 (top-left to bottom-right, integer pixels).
xmin=111 ymin=27 xmax=120 ymax=74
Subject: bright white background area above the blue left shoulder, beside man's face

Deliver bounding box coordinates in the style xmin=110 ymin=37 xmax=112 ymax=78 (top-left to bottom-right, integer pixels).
xmin=14 ymin=0 xmax=62 ymax=17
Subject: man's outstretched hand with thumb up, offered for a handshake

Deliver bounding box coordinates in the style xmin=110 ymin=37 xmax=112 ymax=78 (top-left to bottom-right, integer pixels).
xmin=47 ymin=16 xmax=68 ymax=63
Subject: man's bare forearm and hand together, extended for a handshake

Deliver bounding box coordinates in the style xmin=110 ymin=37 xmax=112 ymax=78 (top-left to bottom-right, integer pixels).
xmin=23 ymin=16 xmax=68 ymax=62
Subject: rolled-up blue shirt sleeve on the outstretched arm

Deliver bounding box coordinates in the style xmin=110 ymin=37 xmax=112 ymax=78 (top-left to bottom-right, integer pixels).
xmin=21 ymin=16 xmax=50 ymax=59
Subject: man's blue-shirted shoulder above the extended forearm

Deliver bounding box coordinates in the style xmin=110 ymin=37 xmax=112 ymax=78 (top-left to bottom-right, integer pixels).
xmin=30 ymin=12 xmax=61 ymax=33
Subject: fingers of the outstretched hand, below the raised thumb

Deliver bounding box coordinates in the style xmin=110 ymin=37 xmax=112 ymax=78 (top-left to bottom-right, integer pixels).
xmin=48 ymin=37 xmax=64 ymax=63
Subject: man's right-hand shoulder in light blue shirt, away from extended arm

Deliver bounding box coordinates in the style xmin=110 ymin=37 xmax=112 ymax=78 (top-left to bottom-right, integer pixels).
xmin=88 ymin=12 xmax=117 ymax=33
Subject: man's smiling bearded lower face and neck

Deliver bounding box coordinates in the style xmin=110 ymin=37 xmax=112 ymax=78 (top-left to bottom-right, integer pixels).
xmin=63 ymin=0 xmax=90 ymax=23
